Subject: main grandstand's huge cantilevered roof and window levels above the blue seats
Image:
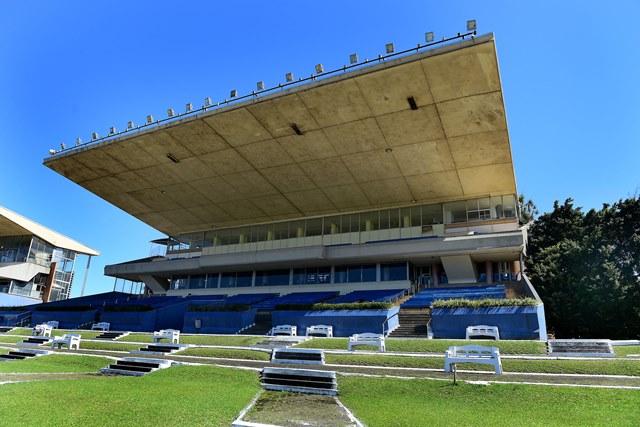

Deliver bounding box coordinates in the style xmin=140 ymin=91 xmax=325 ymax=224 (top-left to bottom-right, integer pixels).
xmin=44 ymin=34 xmax=526 ymax=295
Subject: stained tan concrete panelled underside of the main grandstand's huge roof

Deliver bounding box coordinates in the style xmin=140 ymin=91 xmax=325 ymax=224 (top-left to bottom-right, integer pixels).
xmin=44 ymin=35 xmax=516 ymax=235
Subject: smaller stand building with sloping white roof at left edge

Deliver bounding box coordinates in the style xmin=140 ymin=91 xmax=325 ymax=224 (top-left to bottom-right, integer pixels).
xmin=0 ymin=206 xmax=99 ymax=306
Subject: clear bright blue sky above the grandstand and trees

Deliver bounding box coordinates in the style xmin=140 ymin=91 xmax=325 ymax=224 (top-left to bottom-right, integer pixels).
xmin=0 ymin=0 xmax=640 ymax=296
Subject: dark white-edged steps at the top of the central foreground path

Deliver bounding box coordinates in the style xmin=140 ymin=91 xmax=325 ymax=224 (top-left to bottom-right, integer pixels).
xmin=260 ymin=368 xmax=338 ymax=396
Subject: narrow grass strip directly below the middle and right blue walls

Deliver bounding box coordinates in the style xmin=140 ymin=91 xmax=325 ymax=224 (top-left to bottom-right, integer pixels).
xmin=297 ymin=338 xmax=547 ymax=354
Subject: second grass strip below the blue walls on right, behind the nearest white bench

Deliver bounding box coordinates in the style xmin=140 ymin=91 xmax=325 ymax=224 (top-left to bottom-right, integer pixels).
xmin=325 ymin=353 xmax=640 ymax=376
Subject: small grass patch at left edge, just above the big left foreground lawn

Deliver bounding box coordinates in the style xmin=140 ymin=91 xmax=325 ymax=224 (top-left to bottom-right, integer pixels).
xmin=0 ymin=354 xmax=111 ymax=373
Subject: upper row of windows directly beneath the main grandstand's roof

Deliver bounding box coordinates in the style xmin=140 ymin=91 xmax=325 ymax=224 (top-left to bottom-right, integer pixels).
xmin=168 ymin=195 xmax=516 ymax=252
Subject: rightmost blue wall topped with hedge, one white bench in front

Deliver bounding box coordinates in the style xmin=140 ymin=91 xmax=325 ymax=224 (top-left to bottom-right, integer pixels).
xmin=431 ymin=305 xmax=547 ymax=340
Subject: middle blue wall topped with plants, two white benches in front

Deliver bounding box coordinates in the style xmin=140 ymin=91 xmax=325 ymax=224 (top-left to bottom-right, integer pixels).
xmin=272 ymin=307 xmax=400 ymax=337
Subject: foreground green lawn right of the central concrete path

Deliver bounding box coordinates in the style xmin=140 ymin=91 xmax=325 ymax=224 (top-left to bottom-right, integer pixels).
xmin=338 ymin=376 xmax=640 ymax=426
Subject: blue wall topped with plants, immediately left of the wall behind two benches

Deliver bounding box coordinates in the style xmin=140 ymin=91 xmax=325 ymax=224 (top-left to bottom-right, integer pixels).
xmin=182 ymin=309 xmax=257 ymax=334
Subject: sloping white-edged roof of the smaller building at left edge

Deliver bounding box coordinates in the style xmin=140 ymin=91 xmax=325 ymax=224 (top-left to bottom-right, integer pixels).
xmin=0 ymin=206 xmax=100 ymax=255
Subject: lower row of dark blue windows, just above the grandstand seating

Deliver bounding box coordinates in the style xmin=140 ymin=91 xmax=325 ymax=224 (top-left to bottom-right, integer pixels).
xmin=171 ymin=262 xmax=408 ymax=289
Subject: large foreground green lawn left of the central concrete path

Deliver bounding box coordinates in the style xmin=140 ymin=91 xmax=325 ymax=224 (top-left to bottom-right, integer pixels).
xmin=0 ymin=366 xmax=259 ymax=427
